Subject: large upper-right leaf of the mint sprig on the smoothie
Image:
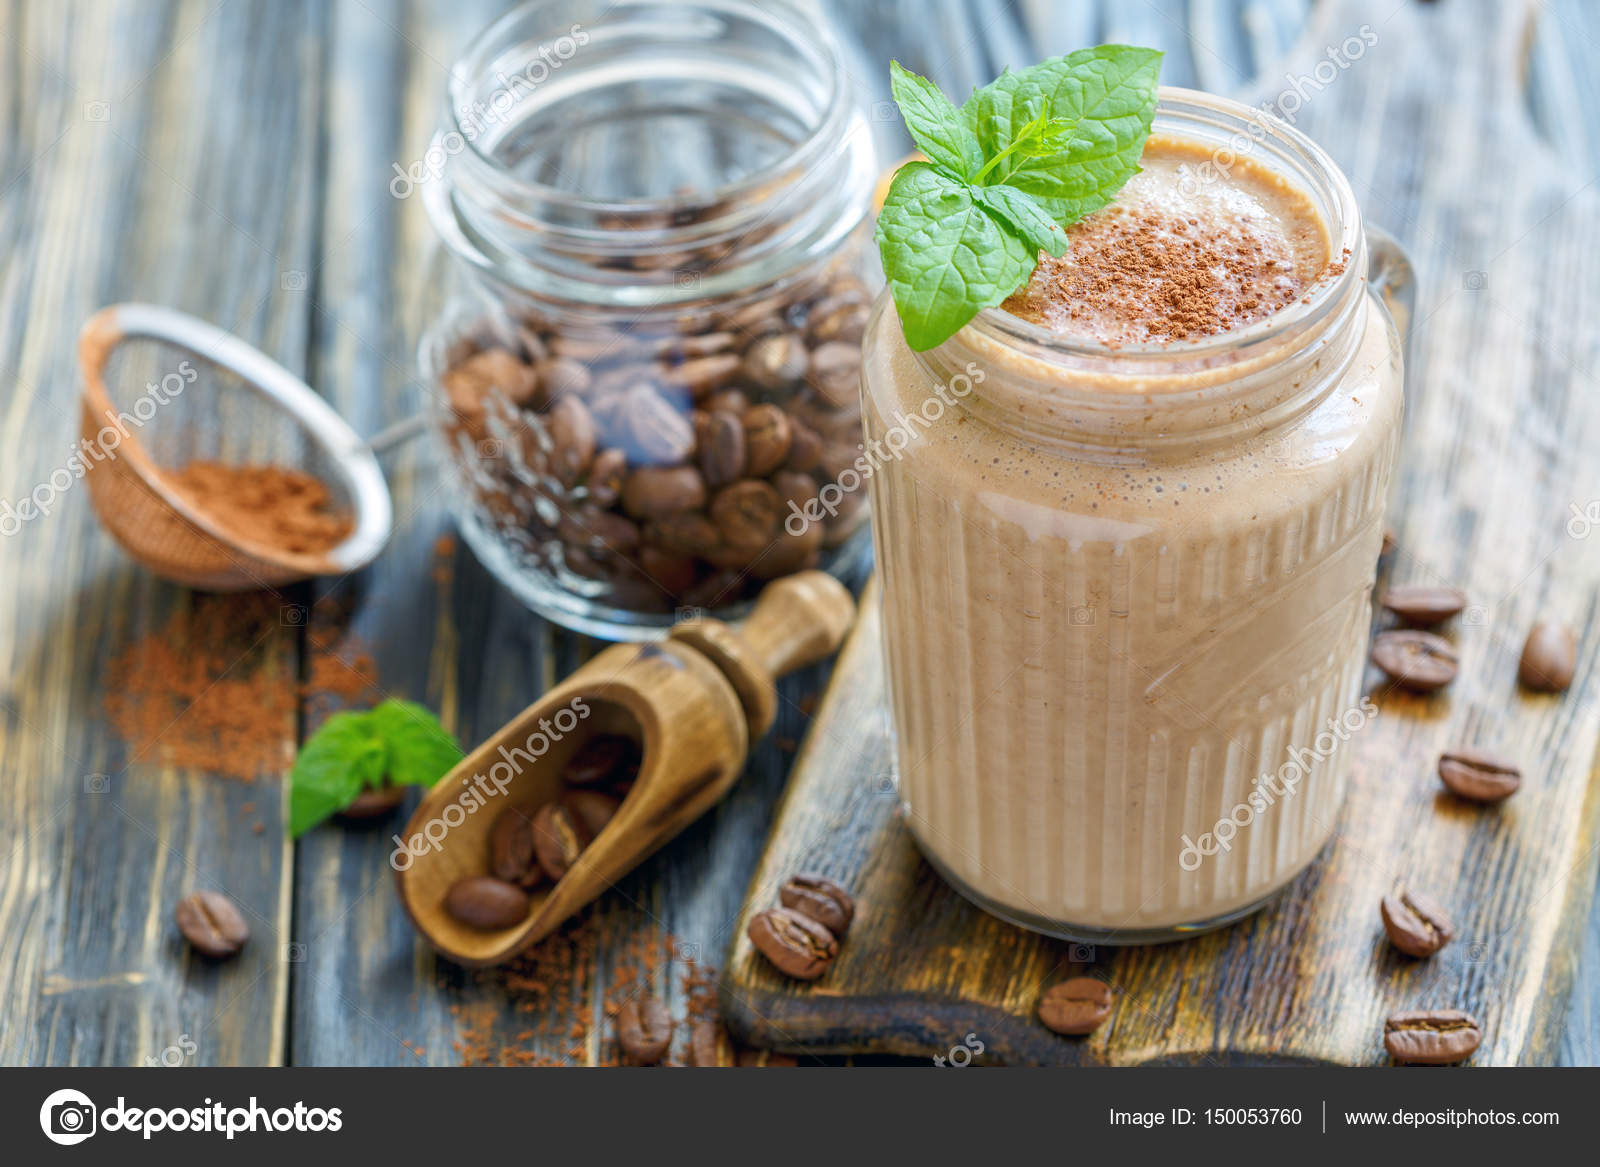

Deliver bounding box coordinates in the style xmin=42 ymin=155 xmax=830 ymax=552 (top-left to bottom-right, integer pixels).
xmin=962 ymin=45 xmax=1162 ymax=226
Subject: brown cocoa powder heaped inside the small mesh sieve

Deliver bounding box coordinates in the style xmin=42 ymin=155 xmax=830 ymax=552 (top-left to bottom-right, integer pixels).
xmin=163 ymin=459 xmax=352 ymax=555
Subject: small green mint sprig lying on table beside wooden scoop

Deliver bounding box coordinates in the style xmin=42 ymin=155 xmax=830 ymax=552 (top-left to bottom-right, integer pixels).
xmin=290 ymin=698 xmax=462 ymax=839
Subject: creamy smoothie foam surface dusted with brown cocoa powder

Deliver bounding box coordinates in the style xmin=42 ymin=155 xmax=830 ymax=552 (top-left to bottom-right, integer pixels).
xmin=1005 ymin=138 xmax=1330 ymax=346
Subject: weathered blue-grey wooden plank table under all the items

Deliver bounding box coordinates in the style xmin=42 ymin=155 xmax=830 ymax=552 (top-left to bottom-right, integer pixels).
xmin=0 ymin=0 xmax=1600 ymax=1065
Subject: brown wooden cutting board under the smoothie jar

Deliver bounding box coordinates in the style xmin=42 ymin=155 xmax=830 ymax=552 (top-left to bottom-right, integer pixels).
xmin=722 ymin=3 xmax=1600 ymax=1065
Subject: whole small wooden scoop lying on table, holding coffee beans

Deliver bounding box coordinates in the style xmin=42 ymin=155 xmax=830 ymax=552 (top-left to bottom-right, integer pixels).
xmin=390 ymin=571 xmax=856 ymax=965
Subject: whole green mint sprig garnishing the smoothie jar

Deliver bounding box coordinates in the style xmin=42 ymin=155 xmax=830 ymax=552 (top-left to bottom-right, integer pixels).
xmin=875 ymin=45 xmax=1162 ymax=352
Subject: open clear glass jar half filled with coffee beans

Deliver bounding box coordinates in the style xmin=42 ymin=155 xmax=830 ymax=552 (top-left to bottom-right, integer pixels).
xmin=416 ymin=0 xmax=877 ymax=639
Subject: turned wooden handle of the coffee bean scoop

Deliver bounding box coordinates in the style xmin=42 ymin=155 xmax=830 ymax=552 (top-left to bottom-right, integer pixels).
xmin=672 ymin=571 xmax=856 ymax=740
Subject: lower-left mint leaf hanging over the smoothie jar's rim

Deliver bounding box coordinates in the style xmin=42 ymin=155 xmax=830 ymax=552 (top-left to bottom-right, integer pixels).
xmin=875 ymin=162 xmax=1038 ymax=352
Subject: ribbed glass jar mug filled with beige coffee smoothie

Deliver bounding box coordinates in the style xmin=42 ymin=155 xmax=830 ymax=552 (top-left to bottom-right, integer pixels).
xmin=862 ymin=90 xmax=1402 ymax=944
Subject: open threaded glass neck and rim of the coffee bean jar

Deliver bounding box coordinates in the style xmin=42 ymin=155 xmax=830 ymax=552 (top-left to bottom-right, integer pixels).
xmin=421 ymin=0 xmax=875 ymax=311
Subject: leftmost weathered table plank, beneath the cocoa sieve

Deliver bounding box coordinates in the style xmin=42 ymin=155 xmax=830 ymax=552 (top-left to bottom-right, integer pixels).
xmin=0 ymin=0 xmax=320 ymax=1065
